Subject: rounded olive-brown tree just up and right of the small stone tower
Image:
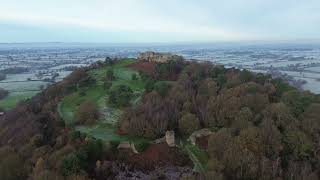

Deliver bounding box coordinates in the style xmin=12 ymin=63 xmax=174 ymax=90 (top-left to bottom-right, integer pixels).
xmin=179 ymin=112 xmax=200 ymax=135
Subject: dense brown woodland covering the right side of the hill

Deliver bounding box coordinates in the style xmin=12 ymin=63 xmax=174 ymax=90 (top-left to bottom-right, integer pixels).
xmin=120 ymin=61 xmax=320 ymax=179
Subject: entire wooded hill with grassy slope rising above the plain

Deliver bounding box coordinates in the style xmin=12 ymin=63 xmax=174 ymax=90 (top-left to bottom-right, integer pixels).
xmin=0 ymin=56 xmax=320 ymax=179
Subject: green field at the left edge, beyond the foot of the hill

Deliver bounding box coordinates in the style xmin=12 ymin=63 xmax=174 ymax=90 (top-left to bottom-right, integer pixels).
xmin=0 ymin=91 xmax=38 ymax=110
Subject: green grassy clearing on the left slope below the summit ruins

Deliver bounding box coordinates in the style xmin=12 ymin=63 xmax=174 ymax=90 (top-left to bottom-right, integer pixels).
xmin=58 ymin=59 xmax=146 ymax=144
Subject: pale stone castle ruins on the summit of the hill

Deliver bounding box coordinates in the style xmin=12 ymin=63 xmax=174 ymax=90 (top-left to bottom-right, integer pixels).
xmin=138 ymin=51 xmax=183 ymax=63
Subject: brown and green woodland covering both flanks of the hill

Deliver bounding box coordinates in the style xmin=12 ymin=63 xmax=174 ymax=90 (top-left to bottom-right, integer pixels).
xmin=0 ymin=57 xmax=320 ymax=180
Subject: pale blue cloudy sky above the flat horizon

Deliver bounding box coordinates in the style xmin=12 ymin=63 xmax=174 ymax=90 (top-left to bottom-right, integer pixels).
xmin=0 ymin=0 xmax=320 ymax=43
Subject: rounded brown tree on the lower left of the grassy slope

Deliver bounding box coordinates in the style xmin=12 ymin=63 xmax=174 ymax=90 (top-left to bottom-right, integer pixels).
xmin=76 ymin=101 xmax=99 ymax=124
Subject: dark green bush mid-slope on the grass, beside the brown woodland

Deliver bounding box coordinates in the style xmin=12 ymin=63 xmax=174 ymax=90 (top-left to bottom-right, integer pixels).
xmin=108 ymin=85 xmax=133 ymax=107
